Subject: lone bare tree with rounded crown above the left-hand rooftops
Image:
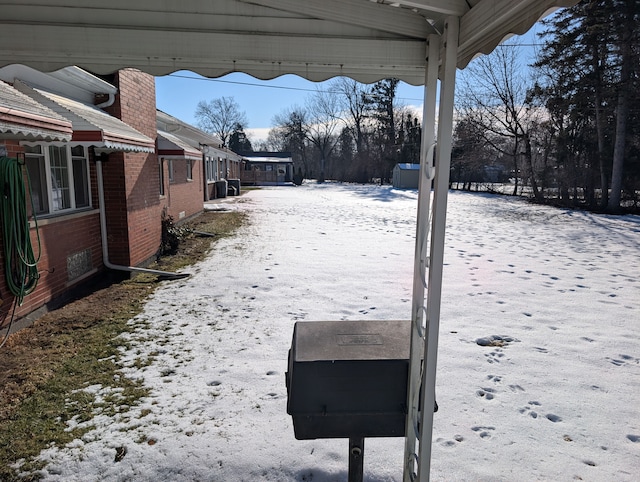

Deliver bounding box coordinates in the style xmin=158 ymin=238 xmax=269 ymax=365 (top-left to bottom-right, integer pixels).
xmin=195 ymin=97 xmax=248 ymax=147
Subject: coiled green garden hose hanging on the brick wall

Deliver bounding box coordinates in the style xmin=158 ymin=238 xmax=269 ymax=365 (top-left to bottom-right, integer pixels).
xmin=0 ymin=157 xmax=41 ymax=306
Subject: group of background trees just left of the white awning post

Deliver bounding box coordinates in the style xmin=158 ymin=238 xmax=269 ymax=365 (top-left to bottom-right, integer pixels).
xmin=267 ymin=78 xmax=421 ymax=183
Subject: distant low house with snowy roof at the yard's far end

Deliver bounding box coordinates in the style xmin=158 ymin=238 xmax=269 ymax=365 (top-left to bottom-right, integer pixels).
xmin=240 ymin=152 xmax=293 ymax=186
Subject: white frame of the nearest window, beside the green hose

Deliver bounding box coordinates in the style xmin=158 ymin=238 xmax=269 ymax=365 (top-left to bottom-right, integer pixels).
xmin=22 ymin=142 xmax=93 ymax=217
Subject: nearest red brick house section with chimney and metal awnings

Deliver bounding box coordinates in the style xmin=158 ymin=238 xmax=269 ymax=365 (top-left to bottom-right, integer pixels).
xmin=0 ymin=65 xmax=209 ymax=334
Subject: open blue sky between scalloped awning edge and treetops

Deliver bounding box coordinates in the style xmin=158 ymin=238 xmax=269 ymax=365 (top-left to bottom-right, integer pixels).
xmin=156 ymin=24 xmax=541 ymax=140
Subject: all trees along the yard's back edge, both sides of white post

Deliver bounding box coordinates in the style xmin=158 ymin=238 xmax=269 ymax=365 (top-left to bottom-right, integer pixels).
xmin=196 ymin=0 xmax=640 ymax=212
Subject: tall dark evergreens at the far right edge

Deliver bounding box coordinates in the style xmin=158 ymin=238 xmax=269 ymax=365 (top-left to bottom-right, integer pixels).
xmin=535 ymin=0 xmax=640 ymax=211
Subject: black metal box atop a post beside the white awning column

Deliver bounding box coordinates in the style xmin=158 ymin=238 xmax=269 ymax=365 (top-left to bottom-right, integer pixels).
xmin=286 ymin=321 xmax=411 ymax=440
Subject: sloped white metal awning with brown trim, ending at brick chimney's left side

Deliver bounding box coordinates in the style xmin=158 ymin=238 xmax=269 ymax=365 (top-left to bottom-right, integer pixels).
xmin=15 ymin=81 xmax=155 ymax=152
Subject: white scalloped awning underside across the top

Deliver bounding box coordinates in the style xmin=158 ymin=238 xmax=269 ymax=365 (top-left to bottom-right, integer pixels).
xmin=0 ymin=0 xmax=577 ymax=85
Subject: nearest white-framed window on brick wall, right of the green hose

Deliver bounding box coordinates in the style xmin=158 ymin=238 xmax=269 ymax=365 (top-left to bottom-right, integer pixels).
xmin=24 ymin=145 xmax=91 ymax=215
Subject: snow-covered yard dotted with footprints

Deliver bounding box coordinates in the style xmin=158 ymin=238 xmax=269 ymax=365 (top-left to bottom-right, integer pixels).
xmin=31 ymin=184 xmax=640 ymax=482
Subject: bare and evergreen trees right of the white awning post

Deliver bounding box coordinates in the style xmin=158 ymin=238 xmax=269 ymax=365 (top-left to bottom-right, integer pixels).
xmin=451 ymin=0 xmax=640 ymax=212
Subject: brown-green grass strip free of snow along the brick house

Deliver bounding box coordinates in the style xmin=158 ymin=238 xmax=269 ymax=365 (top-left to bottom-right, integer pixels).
xmin=0 ymin=208 xmax=247 ymax=482
